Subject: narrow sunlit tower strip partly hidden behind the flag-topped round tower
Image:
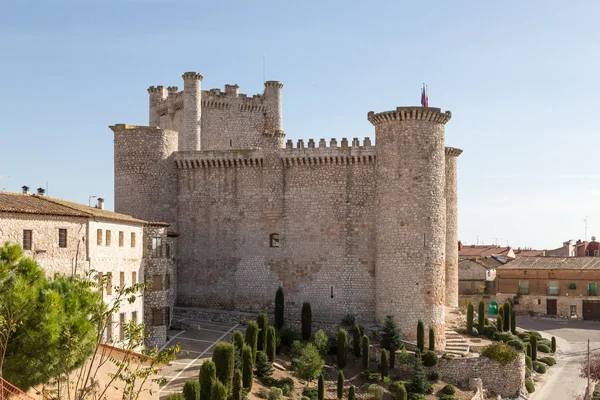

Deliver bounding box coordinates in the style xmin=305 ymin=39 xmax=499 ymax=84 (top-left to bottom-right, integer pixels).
xmin=446 ymin=147 xmax=462 ymax=307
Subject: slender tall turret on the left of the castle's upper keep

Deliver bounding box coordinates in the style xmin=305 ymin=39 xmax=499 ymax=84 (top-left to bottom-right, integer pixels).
xmin=179 ymin=72 xmax=202 ymax=151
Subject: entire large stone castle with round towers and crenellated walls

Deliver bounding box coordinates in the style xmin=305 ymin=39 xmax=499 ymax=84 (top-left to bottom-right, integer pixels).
xmin=111 ymin=72 xmax=462 ymax=348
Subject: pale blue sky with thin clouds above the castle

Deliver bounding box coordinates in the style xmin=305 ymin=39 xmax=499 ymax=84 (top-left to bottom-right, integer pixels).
xmin=0 ymin=0 xmax=600 ymax=248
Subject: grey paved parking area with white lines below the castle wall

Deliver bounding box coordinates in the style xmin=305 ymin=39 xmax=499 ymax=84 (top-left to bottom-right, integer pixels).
xmin=159 ymin=318 xmax=246 ymax=399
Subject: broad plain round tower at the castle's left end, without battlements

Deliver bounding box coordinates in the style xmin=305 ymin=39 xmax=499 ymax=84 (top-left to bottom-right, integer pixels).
xmin=110 ymin=124 xmax=178 ymax=224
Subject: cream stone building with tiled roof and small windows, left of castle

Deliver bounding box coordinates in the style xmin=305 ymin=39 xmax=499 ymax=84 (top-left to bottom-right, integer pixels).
xmin=0 ymin=187 xmax=176 ymax=346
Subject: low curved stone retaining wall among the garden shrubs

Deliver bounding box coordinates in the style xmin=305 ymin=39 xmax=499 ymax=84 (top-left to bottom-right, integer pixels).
xmin=432 ymin=355 xmax=525 ymax=396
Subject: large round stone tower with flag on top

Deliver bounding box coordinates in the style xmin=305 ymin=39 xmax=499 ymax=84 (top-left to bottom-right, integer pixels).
xmin=368 ymin=107 xmax=450 ymax=349
